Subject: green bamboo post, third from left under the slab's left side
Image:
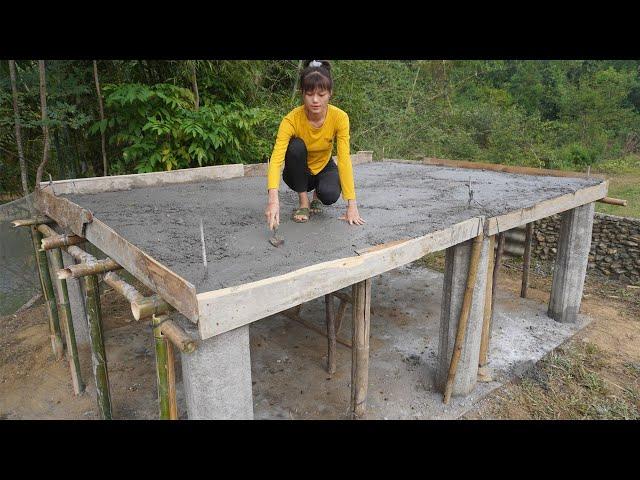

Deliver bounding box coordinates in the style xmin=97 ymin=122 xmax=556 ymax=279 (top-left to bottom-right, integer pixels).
xmin=82 ymin=275 xmax=112 ymax=420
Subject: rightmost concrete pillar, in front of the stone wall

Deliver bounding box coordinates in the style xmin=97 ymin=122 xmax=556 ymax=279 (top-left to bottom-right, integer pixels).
xmin=548 ymin=203 xmax=595 ymax=323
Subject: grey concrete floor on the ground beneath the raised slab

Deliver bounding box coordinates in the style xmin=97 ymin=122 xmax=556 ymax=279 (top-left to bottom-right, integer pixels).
xmin=250 ymin=265 xmax=589 ymax=420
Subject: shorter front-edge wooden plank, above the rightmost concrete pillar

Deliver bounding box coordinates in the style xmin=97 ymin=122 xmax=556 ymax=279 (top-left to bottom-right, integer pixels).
xmin=485 ymin=180 xmax=609 ymax=235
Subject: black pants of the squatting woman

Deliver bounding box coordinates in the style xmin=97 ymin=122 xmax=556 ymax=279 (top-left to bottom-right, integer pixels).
xmin=282 ymin=138 xmax=341 ymax=205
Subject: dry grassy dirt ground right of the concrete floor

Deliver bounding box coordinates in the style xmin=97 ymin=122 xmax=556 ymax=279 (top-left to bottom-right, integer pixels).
xmin=461 ymin=262 xmax=640 ymax=420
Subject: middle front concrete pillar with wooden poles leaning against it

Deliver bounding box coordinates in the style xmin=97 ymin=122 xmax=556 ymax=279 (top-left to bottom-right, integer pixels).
xmin=436 ymin=237 xmax=490 ymax=395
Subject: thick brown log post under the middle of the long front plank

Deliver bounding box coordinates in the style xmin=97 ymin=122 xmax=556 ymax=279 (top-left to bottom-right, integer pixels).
xmin=351 ymin=278 xmax=371 ymax=418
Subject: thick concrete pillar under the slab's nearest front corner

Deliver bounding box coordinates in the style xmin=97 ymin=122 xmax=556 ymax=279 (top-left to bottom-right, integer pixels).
xmin=181 ymin=325 xmax=253 ymax=420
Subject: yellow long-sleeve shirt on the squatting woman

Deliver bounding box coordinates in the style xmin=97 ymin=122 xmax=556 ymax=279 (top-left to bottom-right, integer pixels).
xmin=267 ymin=105 xmax=356 ymax=200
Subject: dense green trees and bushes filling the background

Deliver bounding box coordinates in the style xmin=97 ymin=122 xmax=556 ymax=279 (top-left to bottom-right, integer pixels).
xmin=0 ymin=60 xmax=640 ymax=197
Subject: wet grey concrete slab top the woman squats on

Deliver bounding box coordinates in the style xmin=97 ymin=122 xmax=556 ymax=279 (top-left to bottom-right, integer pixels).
xmin=62 ymin=162 xmax=600 ymax=292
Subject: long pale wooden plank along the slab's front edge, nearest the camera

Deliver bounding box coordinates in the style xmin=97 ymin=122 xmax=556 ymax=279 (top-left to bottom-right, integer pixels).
xmin=197 ymin=217 xmax=485 ymax=339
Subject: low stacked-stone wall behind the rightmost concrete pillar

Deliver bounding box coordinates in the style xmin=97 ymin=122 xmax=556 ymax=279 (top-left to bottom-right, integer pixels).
xmin=532 ymin=213 xmax=640 ymax=284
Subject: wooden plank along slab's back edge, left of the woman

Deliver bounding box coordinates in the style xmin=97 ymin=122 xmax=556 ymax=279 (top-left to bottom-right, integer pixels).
xmin=40 ymin=163 xmax=244 ymax=195
